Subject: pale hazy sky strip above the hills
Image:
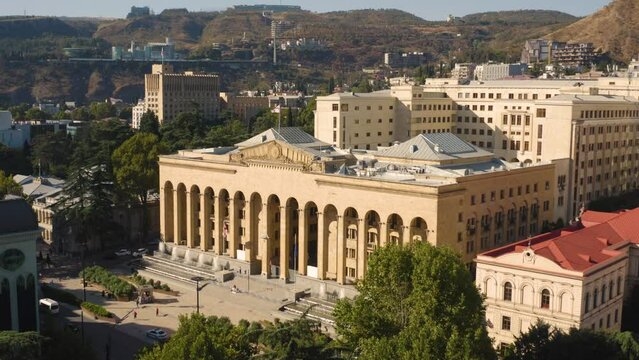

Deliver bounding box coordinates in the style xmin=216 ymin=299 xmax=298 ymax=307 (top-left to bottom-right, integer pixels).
xmin=0 ymin=0 xmax=610 ymax=20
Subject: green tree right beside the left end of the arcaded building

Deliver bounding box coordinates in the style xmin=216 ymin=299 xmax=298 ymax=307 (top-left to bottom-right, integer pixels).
xmin=112 ymin=132 xmax=168 ymax=243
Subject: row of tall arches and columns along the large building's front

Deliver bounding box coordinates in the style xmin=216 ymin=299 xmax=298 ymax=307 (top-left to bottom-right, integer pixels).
xmin=160 ymin=182 xmax=429 ymax=284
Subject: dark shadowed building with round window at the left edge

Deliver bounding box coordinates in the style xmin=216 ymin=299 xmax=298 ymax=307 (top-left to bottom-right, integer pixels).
xmin=0 ymin=199 xmax=40 ymax=331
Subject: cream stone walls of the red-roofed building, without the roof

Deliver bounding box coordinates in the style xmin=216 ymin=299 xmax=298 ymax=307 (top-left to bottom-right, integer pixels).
xmin=476 ymin=252 xmax=627 ymax=346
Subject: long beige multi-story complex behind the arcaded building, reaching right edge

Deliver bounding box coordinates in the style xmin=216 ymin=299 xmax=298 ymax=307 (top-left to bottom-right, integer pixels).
xmin=315 ymin=78 xmax=639 ymax=222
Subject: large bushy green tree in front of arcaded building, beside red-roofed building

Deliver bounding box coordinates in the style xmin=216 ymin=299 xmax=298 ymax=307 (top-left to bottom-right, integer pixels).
xmin=335 ymin=243 xmax=496 ymax=359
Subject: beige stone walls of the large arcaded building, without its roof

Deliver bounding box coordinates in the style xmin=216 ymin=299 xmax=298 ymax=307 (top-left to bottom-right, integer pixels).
xmin=160 ymin=142 xmax=554 ymax=284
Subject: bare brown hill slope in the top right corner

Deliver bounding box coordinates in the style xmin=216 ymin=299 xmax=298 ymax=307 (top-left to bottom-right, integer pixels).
xmin=547 ymin=0 xmax=639 ymax=62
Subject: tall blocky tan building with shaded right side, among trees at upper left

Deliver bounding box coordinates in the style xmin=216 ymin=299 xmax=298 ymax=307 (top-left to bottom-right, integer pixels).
xmin=144 ymin=64 xmax=220 ymax=124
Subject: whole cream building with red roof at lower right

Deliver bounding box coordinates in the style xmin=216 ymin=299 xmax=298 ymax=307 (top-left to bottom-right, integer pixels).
xmin=476 ymin=209 xmax=639 ymax=346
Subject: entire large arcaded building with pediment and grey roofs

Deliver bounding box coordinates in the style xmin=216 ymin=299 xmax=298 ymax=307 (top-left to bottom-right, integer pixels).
xmin=160 ymin=128 xmax=555 ymax=292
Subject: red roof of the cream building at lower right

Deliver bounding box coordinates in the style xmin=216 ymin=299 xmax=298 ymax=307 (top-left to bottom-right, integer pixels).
xmin=480 ymin=208 xmax=639 ymax=271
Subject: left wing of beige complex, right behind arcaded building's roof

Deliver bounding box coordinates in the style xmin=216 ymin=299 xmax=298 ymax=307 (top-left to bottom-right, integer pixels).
xmin=315 ymin=85 xmax=455 ymax=150
